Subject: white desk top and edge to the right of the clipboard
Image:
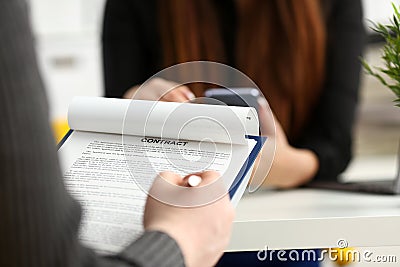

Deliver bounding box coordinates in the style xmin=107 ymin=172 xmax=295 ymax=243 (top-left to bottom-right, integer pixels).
xmin=227 ymin=189 xmax=400 ymax=251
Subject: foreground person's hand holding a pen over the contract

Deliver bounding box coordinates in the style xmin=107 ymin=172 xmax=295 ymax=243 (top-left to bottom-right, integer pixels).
xmin=144 ymin=171 xmax=234 ymax=267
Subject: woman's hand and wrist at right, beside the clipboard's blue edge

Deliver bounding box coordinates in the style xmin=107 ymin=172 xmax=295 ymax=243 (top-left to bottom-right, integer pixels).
xmin=259 ymin=99 xmax=318 ymax=188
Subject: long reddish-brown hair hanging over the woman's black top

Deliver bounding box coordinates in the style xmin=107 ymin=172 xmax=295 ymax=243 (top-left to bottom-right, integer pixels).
xmin=159 ymin=0 xmax=326 ymax=139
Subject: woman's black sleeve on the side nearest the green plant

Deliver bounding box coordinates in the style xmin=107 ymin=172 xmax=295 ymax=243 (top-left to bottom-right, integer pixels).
xmin=296 ymin=0 xmax=365 ymax=180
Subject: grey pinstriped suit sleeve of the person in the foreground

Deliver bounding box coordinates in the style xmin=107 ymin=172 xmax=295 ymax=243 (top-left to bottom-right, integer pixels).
xmin=0 ymin=0 xmax=183 ymax=267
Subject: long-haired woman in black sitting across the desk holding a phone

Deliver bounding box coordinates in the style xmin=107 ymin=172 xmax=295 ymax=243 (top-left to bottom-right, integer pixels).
xmin=102 ymin=0 xmax=365 ymax=266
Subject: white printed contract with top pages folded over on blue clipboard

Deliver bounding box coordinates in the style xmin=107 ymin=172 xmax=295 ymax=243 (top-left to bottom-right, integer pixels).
xmin=59 ymin=97 xmax=262 ymax=254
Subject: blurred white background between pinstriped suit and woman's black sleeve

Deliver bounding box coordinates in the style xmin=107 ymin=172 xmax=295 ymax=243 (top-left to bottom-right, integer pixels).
xmin=29 ymin=0 xmax=105 ymax=120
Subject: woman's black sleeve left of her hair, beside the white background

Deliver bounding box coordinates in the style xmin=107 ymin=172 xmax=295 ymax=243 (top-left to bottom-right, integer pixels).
xmin=102 ymin=0 xmax=161 ymax=97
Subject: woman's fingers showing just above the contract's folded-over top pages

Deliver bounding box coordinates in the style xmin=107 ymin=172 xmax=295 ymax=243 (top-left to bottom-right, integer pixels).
xmin=123 ymin=78 xmax=195 ymax=102
